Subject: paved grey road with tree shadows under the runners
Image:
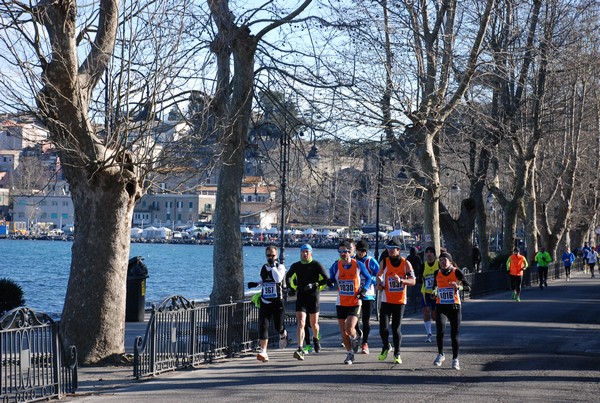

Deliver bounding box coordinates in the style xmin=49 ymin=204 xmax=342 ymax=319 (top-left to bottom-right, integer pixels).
xmin=67 ymin=273 xmax=600 ymax=403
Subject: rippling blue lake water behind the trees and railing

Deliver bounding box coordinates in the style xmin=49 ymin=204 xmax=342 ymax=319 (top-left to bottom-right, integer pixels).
xmin=0 ymin=239 xmax=338 ymax=314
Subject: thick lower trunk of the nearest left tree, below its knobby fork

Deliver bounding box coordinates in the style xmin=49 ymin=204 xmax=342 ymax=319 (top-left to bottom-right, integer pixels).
xmin=61 ymin=166 xmax=137 ymax=364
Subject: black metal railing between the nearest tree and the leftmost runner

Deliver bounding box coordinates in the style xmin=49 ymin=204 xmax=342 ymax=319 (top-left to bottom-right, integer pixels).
xmin=133 ymin=295 xmax=279 ymax=379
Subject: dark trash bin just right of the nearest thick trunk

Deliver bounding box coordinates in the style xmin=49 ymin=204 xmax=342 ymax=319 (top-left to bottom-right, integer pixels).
xmin=125 ymin=256 xmax=148 ymax=322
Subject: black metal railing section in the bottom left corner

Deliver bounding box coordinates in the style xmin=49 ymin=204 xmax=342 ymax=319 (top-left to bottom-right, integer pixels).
xmin=0 ymin=308 xmax=77 ymax=402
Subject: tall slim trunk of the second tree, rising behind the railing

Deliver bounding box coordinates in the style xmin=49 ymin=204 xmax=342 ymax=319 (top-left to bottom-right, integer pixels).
xmin=209 ymin=1 xmax=256 ymax=304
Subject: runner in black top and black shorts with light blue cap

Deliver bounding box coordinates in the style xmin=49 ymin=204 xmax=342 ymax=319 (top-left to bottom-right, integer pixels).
xmin=286 ymin=244 xmax=329 ymax=361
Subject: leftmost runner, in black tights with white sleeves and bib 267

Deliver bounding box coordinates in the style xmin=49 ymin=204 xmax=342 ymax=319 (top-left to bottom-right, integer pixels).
xmin=248 ymin=246 xmax=287 ymax=362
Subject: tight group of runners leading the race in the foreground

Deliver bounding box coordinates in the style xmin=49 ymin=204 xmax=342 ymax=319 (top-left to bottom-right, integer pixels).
xmin=248 ymin=239 xmax=469 ymax=370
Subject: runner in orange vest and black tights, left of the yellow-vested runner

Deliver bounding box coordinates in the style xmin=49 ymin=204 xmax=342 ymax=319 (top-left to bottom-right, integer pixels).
xmin=377 ymin=240 xmax=416 ymax=364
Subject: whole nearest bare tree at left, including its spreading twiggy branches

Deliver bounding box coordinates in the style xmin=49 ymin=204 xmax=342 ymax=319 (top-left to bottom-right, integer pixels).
xmin=0 ymin=0 xmax=196 ymax=364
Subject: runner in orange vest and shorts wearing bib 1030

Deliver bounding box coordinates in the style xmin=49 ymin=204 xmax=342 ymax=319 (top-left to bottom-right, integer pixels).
xmin=329 ymin=241 xmax=372 ymax=365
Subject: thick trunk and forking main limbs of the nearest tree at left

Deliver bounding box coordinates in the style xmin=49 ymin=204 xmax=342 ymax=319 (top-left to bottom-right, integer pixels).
xmin=34 ymin=0 xmax=142 ymax=364
